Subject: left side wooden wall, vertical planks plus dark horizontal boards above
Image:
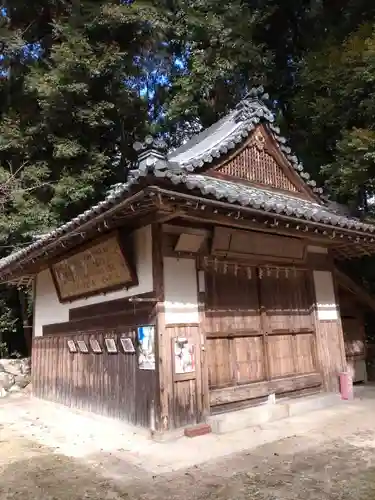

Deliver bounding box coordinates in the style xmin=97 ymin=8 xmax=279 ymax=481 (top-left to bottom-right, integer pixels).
xmin=32 ymin=296 xmax=158 ymax=428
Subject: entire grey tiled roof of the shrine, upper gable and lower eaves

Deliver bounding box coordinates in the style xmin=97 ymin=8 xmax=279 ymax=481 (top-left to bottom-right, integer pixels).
xmin=0 ymin=89 xmax=375 ymax=274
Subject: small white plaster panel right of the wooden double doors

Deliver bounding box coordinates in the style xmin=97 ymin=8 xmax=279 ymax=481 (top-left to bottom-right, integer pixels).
xmin=313 ymin=271 xmax=338 ymax=321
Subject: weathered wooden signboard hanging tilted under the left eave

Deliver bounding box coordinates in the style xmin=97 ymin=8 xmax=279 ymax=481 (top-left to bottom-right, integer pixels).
xmin=51 ymin=234 xmax=137 ymax=302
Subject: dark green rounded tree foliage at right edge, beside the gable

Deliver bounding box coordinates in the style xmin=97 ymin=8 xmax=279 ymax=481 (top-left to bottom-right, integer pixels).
xmin=294 ymin=24 xmax=375 ymax=209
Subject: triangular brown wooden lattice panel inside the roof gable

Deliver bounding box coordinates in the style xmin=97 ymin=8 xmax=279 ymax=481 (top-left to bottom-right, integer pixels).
xmin=210 ymin=125 xmax=311 ymax=196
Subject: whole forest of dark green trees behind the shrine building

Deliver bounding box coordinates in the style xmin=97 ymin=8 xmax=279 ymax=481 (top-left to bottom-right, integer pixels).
xmin=0 ymin=0 xmax=375 ymax=357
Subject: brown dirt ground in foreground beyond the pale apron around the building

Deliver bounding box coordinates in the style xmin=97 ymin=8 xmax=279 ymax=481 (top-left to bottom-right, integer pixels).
xmin=0 ymin=388 xmax=375 ymax=500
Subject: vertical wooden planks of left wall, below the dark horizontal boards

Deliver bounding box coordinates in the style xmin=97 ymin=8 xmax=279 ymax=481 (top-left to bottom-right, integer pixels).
xmin=32 ymin=332 xmax=155 ymax=427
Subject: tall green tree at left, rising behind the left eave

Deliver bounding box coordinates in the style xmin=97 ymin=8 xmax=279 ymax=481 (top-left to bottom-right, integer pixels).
xmin=0 ymin=0 xmax=170 ymax=354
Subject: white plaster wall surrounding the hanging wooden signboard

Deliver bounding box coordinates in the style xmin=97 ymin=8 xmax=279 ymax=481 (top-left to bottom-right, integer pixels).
xmin=34 ymin=226 xmax=153 ymax=337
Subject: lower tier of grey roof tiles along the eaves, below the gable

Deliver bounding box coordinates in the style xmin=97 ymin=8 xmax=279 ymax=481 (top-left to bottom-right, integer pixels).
xmin=0 ymin=165 xmax=375 ymax=273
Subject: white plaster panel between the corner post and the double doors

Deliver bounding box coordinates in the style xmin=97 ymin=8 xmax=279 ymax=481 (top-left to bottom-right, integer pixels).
xmin=163 ymin=257 xmax=199 ymax=325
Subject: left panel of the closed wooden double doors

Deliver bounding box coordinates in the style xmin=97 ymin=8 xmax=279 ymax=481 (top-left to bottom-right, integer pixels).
xmin=205 ymin=267 xmax=265 ymax=388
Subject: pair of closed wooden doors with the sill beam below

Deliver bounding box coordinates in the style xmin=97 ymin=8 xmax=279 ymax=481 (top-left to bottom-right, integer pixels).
xmin=205 ymin=263 xmax=320 ymax=405
